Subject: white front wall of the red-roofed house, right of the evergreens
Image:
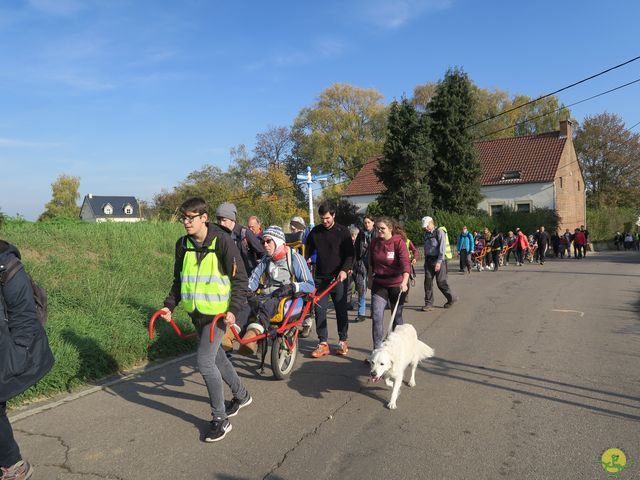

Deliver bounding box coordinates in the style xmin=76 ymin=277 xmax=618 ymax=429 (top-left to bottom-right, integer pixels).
xmin=478 ymin=182 xmax=555 ymax=212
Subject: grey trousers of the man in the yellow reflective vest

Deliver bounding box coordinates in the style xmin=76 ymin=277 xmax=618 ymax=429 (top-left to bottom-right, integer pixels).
xmin=195 ymin=320 xmax=248 ymax=420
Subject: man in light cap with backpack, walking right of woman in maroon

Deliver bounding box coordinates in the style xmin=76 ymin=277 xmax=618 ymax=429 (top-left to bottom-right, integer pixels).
xmin=421 ymin=217 xmax=456 ymax=312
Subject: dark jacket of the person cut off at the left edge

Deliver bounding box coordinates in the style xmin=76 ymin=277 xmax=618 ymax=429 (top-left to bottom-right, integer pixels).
xmin=0 ymin=241 xmax=54 ymax=402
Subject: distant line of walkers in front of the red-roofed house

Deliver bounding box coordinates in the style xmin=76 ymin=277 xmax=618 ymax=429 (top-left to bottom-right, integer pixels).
xmin=457 ymin=225 xmax=589 ymax=273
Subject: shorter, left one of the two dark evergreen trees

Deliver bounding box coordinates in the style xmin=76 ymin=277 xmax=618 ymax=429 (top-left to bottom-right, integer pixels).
xmin=376 ymin=98 xmax=433 ymax=220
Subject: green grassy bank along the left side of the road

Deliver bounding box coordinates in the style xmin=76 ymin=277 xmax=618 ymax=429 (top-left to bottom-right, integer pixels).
xmin=0 ymin=221 xmax=200 ymax=406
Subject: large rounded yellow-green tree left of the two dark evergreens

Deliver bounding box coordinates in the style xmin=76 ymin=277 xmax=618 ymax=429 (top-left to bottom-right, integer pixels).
xmin=292 ymin=84 xmax=386 ymax=179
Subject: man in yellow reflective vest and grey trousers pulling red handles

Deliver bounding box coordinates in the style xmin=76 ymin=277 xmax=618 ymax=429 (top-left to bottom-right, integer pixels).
xmin=162 ymin=197 xmax=252 ymax=442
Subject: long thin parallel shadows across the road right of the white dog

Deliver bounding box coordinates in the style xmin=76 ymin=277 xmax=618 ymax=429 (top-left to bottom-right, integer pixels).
xmin=420 ymin=357 xmax=640 ymax=421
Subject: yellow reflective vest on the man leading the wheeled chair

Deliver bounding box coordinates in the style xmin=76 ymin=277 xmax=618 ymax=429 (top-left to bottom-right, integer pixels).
xmin=180 ymin=237 xmax=231 ymax=315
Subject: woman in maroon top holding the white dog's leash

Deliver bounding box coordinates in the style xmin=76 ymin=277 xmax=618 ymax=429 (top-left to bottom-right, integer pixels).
xmin=369 ymin=217 xmax=411 ymax=349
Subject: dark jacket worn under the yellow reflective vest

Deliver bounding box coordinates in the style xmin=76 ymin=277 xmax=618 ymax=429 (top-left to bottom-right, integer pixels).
xmin=164 ymin=223 xmax=248 ymax=317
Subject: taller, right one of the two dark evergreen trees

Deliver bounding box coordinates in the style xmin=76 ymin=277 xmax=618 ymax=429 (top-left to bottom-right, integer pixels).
xmin=427 ymin=68 xmax=482 ymax=213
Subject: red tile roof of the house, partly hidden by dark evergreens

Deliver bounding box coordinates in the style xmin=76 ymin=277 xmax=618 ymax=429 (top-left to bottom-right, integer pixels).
xmin=342 ymin=132 xmax=567 ymax=197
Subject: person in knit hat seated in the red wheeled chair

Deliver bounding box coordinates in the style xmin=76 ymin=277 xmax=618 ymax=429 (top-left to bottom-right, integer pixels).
xmin=228 ymin=225 xmax=315 ymax=356
